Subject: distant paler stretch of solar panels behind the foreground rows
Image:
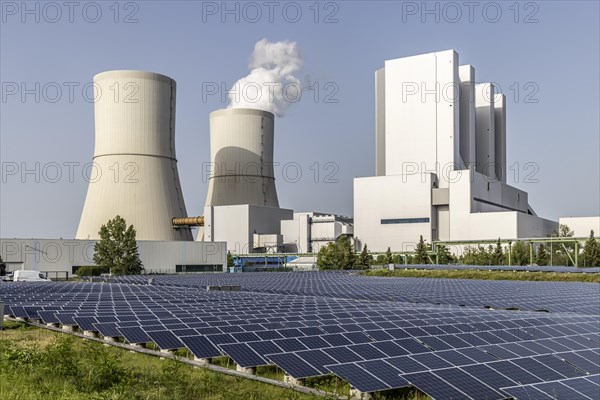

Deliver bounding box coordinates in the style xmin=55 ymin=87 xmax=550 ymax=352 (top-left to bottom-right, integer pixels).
xmin=110 ymin=272 xmax=600 ymax=313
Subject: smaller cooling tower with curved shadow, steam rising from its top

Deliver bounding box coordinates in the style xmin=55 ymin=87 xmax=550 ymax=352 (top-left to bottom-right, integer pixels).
xmin=206 ymin=108 xmax=279 ymax=207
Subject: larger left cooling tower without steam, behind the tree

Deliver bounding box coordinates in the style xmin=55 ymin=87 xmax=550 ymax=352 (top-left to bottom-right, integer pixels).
xmin=76 ymin=71 xmax=192 ymax=240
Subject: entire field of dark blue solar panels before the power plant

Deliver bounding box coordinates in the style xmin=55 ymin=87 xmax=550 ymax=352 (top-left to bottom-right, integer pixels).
xmin=0 ymin=273 xmax=600 ymax=399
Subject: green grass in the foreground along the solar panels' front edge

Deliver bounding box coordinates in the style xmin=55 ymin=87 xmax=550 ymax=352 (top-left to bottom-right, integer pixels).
xmin=0 ymin=321 xmax=428 ymax=400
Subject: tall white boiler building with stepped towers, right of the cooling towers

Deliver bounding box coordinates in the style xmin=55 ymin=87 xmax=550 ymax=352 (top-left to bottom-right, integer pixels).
xmin=354 ymin=50 xmax=558 ymax=251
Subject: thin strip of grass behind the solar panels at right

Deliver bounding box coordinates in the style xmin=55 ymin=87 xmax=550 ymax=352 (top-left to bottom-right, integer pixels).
xmin=364 ymin=267 xmax=600 ymax=283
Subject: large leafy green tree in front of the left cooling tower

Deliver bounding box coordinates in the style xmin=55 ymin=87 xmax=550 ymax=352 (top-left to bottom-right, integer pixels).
xmin=94 ymin=215 xmax=144 ymax=275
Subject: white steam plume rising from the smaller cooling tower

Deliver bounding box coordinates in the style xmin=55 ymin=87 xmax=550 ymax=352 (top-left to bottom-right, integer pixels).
xmin=228 ymin=39 xmax=302 ymax=117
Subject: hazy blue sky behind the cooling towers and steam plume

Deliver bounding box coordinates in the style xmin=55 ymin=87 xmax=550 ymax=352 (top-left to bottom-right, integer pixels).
xmin=0 ymin=1 xmax=600 ymax=238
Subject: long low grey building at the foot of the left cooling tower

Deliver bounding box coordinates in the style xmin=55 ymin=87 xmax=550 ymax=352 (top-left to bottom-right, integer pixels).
xmin=0 ymin=238 xmax=227 ymax=275
